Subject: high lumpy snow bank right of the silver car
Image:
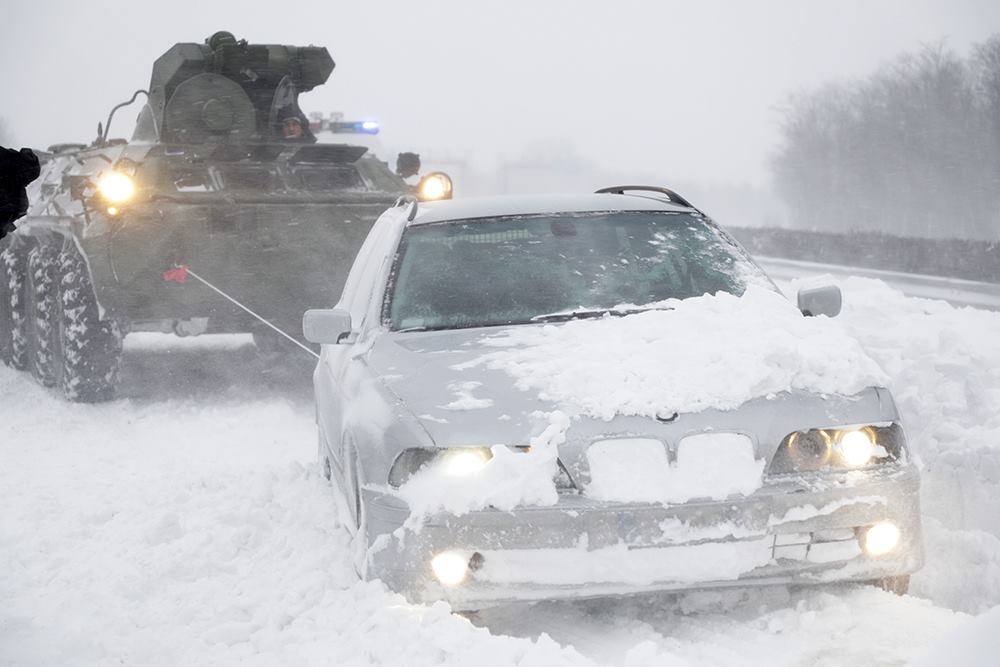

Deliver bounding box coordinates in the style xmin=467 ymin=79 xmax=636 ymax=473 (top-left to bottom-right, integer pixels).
xmin=828 ymin=278 xmax=1000 ymax=612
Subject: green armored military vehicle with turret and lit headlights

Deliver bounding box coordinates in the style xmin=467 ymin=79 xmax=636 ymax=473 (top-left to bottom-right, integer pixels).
xmin=0 ymin=32 xmax=451 ymax=402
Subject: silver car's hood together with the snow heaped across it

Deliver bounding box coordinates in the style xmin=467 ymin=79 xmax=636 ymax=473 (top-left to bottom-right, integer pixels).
xmin=369 ymin=287 xmax=887 ymax=446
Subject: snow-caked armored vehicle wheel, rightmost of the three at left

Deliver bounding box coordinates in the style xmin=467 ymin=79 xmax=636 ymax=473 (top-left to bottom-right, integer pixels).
xmin=55 ymin=246 xmax=122 ymax=403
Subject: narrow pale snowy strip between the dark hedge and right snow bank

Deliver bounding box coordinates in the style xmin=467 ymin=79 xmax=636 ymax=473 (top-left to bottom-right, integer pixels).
xmin=755 ymin=256 xmax=1000 ymax=310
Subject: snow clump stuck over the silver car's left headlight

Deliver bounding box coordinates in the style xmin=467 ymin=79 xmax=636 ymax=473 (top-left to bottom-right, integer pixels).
xmin=398 ymin=411 xmax=570 ymax=516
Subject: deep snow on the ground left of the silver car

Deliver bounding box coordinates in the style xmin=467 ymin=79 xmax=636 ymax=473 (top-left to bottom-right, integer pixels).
xmin=0 ymin=370 xmax=593 ymax=667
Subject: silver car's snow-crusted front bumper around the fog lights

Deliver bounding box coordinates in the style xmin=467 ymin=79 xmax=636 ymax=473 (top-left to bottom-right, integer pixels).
xmin=365 ymin=465 xmax=923 ymax=610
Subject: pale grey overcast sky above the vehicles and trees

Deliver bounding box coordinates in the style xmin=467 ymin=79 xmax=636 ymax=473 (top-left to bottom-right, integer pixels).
xmin=0 ymin=0 xmax=1000 ymax=190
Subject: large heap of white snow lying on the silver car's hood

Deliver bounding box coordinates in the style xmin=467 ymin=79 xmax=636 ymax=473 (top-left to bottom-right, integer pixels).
xmin=464 ymin=286 xmax=887 ymax=420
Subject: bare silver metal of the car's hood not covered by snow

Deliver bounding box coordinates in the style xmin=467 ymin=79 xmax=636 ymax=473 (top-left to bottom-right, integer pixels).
xmin=369 ymin=325 xmax=897 ymax=468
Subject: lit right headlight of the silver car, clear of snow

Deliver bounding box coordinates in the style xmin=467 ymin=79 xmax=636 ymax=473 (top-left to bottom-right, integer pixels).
xmin=768 ymin=424 xmax=906 ymax=475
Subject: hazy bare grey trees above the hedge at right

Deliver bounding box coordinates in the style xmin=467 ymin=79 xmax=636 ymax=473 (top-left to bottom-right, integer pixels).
xmin=772 ymin=34 xmax=1000 ymax=240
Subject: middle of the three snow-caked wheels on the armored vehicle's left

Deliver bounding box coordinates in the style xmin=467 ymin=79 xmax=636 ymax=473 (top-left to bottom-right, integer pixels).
xmin=25 ymin=243 xmax=59 ymax=387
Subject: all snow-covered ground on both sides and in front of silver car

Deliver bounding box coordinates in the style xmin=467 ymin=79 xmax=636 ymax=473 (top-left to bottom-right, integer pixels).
xmin=0 ymin=279 xmax=1000 ymax=667
